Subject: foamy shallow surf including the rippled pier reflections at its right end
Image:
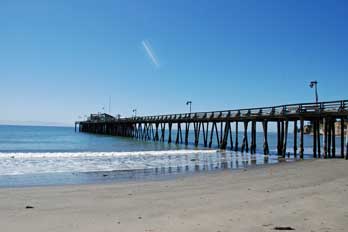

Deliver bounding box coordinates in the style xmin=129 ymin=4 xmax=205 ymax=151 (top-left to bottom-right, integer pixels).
xmin=0 ymin=149 xmax=274 ymax=176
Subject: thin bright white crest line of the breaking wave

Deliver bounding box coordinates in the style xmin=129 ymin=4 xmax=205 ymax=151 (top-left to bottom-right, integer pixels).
xmin=0 ymin=150 xmax=217 ymax=159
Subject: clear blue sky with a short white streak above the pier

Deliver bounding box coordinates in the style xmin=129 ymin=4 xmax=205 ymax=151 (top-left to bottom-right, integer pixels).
xmin=0 ymin=0 xmax=348 ymax=123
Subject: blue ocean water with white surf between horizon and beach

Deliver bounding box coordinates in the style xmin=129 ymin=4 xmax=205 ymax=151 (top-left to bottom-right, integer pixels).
xmin=0 ymin=125 xmax=339 ymax=187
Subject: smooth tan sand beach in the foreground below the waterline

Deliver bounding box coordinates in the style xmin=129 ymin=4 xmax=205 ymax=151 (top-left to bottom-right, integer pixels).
xmin=0 ymin=159 xmax=348 ymax=232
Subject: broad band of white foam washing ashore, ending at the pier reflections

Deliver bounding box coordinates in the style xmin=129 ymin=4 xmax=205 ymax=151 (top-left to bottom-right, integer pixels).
xmin=0 ymin=150 xmax=223 ymax=175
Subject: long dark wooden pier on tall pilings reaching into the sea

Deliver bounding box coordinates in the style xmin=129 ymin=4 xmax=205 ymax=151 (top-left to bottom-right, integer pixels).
xmin=75 ymin=100 xmax=348 ymax=159
